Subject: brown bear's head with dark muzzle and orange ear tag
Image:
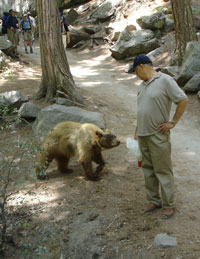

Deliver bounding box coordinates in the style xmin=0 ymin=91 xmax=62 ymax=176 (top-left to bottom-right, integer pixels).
xmin=94 ymin=131 xmax=120 ymax=150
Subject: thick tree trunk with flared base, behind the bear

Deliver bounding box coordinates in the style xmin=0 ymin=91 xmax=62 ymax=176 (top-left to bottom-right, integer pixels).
xmin=36 ymin=0 xmax=83 ymax=103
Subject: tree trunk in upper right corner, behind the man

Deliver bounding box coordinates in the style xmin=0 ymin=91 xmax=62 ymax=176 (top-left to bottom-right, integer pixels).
xmin=171 ymin=0 xmax=197 ymax=65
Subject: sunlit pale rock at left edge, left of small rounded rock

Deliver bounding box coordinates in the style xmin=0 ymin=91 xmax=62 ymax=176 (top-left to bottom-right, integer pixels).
xmin=1 ymin=91 xmax=28 ymax=110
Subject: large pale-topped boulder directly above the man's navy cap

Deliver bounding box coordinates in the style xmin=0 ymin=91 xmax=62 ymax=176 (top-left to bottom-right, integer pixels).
xmin=110 ymin=30 xmax=159 ymax=59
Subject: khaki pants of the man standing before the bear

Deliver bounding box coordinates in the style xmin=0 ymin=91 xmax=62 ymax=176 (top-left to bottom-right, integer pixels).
xmin=138 ymin=133 xmax=174 ymax=208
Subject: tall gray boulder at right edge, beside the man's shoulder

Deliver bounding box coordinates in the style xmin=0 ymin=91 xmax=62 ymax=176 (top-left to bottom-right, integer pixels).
xmin=176 ymin=41 xmax=200 ymax=87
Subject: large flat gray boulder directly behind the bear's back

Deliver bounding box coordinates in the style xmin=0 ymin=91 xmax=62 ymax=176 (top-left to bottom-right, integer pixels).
xmin=33 ymin=104 xmax=105 ymax=140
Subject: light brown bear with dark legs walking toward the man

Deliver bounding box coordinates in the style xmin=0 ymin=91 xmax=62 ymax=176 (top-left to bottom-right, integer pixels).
xmin=36 ymin=121 xmax=120 ymax=180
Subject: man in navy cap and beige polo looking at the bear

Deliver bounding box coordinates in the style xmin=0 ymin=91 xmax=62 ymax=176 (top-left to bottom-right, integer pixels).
xmin=128 ymin=55 xmax=188 ymax=219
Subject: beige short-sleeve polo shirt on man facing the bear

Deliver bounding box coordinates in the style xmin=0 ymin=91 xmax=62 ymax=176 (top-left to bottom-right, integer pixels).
xmin=137 ymin=72 xmax=187 ymax=136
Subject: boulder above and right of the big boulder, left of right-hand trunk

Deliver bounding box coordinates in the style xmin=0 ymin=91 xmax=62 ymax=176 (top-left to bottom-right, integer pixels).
xmin=136 ymin=12 xmax=165 ymax=30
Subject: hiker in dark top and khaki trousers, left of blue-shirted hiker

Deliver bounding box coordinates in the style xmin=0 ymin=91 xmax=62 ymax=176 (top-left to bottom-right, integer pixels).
xmin=5 ymin=9 xmax=18 ymax=57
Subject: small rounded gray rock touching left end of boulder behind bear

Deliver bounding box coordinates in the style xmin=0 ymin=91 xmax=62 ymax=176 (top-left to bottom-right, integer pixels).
xmin=19 ymin=102 xmax=41 ymax=119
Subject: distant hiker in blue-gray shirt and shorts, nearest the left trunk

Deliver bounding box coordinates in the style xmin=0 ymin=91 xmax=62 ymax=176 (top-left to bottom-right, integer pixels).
xmin=20 ymin=14 xmax=33 ymax=54
